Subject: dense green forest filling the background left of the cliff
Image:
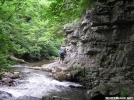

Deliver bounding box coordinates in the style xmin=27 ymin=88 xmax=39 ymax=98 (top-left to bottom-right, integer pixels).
xmin=0 ymin=0 xmax=92 ymax=70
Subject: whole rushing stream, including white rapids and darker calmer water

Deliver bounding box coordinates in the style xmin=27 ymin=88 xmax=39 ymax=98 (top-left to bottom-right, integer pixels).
xmin=0 ymin=61 xmax=89 ymax=100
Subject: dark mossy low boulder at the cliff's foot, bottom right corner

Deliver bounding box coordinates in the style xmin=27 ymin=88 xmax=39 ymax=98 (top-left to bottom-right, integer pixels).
xmin=87 ymin=83 xmax=131 ymax=100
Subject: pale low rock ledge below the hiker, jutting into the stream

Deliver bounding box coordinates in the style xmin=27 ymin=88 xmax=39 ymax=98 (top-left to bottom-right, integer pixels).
xmin=28 ymin=61 xmax=73 ymax=81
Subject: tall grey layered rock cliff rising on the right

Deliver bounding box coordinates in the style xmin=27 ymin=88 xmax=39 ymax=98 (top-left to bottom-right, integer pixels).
xmin=64 ymin=0 xmax=134 ymax=92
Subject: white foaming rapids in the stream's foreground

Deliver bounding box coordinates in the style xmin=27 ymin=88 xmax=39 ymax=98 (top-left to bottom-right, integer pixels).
xmin=0 ymin=65 xmax=84 ymax=98
